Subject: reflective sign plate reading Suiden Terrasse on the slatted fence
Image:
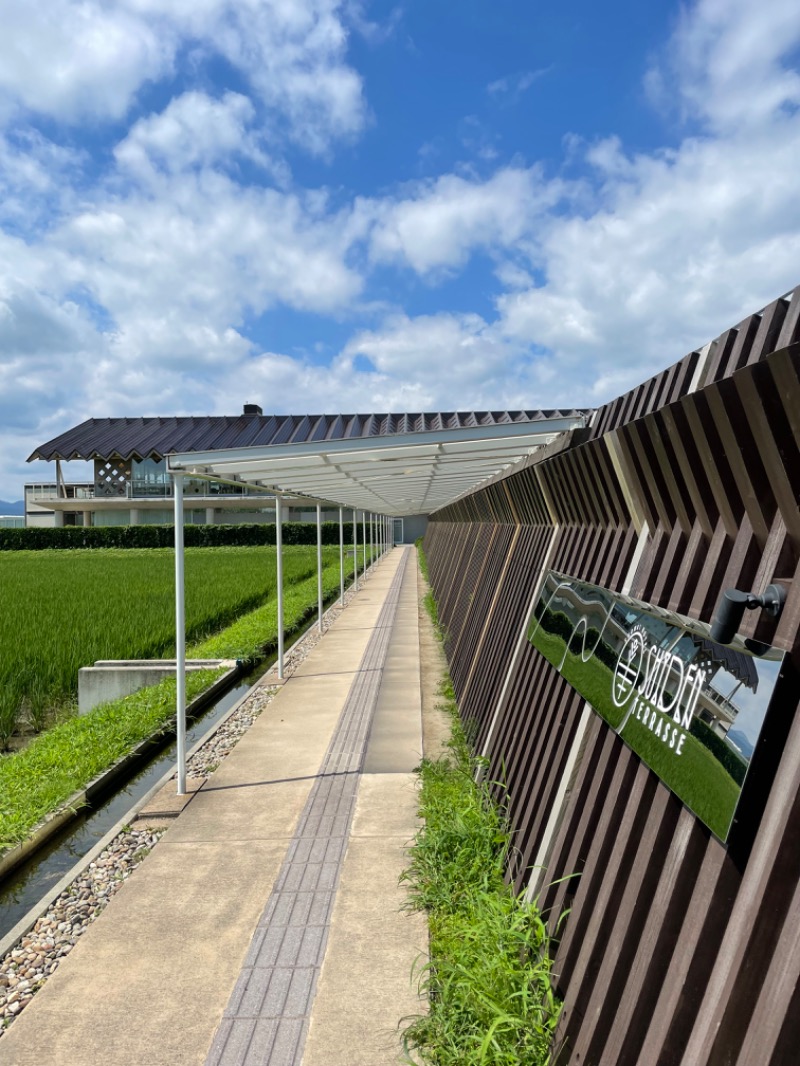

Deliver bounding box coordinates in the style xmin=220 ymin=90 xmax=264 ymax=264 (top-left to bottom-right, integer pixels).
xmin=528 ymin=570 xmax=784 ymax=841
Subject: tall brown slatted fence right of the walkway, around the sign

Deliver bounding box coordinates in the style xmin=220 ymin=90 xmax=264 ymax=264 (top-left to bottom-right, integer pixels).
xmin=425 ymin=288 xmax=800 ymax=1066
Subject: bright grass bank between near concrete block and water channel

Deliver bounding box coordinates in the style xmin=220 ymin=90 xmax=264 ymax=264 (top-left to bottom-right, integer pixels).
xmin=0 ymin=668 xmax=224 ymax=851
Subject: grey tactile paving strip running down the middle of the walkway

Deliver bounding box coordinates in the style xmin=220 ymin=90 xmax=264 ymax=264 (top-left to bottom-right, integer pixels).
xmin=206 ymin=555 xmax=409 ymax=1066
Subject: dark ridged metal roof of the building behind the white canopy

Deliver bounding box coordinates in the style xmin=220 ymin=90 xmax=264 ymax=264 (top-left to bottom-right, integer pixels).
xmin=28 ymin=409 xmax=590 ymax=463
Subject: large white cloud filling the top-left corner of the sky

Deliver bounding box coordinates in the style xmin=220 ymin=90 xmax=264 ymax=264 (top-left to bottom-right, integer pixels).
xmin=0 ymin=0 xmax=366 ymax=152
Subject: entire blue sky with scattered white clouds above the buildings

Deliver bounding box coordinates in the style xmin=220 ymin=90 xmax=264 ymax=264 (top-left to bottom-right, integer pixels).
xmin=0 ymin=0 xmax=800 ymax=499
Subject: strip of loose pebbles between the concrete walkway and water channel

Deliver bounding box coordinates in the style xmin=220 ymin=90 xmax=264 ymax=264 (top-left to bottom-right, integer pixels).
xmin=0 ymin=586 xmax=366 ymax=1037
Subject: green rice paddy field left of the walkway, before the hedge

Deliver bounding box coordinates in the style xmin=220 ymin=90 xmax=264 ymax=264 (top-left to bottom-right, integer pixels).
xmin=0 ymin=546 xmax=349 ymax=742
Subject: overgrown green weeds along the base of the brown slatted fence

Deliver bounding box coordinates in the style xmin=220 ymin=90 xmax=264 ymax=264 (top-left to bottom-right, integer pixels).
xmin=403 ymin=682 xmax=560 ymax=1066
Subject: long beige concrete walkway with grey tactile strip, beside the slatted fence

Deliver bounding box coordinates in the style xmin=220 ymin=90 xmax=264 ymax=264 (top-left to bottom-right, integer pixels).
xmin=0 ymin=548 xmax=427 ymax=1066
